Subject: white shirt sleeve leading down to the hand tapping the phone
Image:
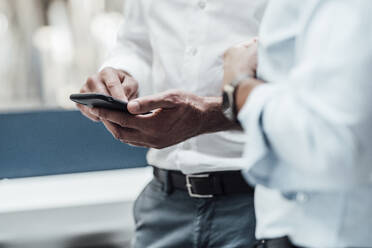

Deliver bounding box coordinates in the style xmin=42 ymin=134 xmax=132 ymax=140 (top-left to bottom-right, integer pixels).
xmin=100 ymin=0 xmax=152 ymax=95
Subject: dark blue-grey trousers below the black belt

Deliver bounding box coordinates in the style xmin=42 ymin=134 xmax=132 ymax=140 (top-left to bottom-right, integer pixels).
xmin=133 ymin=179 xmax=256 ymax=248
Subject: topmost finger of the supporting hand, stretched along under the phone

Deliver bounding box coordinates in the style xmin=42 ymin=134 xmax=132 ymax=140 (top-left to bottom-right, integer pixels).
xmin=90 ymin=108 xmax=147 ymax=130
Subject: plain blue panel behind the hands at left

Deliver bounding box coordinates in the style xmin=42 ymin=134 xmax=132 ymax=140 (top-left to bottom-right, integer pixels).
xmin=0 ymin=111 xmax=147 ymax=178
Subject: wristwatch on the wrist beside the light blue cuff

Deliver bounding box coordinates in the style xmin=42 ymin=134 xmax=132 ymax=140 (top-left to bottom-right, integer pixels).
xmin=222 ymin=76 xmax=250 ymax=122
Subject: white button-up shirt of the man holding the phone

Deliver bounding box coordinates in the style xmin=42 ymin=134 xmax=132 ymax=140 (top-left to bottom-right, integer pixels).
xmin=103 ymin=0 xmax=266 ymax=174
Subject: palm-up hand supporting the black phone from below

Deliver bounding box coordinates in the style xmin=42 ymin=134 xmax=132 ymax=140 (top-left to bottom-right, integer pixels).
xmin=88 ymin=90 xmax=235 ymax=149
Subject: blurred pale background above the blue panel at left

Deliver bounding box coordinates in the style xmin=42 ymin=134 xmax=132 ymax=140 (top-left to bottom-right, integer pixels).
xmin=0 ymin=0 xmax=124 ymax=111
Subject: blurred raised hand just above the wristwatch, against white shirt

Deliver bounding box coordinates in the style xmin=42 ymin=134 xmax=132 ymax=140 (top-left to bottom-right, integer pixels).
xmin=223 ymin=38 xmax=258 ymax=85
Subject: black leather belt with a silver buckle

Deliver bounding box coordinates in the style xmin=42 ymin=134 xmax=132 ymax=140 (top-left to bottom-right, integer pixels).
xmin=154 ymin=167 xmax=254 ymax=198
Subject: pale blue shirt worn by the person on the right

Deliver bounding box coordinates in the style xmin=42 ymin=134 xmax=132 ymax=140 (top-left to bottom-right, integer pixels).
xmin=239 ymin=0 xmax=372 ymax=248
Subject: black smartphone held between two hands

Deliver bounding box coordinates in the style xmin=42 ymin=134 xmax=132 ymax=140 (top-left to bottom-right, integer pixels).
xmin=70 ymin=93 xmax=129 ymax=113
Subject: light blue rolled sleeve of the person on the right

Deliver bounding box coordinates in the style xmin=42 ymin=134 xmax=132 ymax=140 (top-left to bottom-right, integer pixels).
xmin=238 ymin=0 xmax=372 ymax=191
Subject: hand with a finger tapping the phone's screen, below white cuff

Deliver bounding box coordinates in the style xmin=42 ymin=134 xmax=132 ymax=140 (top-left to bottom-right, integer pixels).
xmin=77 ymin=67 xmax=138 ymax=121
